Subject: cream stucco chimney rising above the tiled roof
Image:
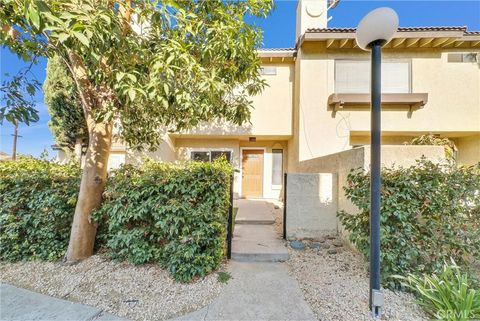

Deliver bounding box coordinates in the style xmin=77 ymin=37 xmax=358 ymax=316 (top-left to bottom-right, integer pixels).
xmin=295 ymin=0 xmax=328 ymax=41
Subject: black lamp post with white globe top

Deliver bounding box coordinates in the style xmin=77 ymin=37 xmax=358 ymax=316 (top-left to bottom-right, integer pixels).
xmin=355 ymin=8 xmax=398 ymax=318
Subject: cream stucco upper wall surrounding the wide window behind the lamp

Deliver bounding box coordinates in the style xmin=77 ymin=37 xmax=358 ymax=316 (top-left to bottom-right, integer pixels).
xmin=292 ymin=43 xmax=480 ymax=167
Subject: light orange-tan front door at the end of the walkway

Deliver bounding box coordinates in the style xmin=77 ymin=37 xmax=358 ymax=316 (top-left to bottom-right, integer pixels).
xmin=242 ymin=149 xmax=263 ymax=197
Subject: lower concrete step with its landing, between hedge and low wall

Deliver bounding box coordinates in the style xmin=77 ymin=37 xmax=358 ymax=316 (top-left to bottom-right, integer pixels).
xmin=232 ymin=224 xmax=289 ymax=262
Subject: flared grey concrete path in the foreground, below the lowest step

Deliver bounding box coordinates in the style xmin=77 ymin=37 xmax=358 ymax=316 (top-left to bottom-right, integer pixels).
xmin=176 ymin=261 xmax=317 ymax=321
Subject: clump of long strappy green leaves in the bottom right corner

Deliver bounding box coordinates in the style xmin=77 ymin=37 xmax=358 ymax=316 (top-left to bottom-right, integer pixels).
xmin=400 ymin=260 xmax=480 ymax=321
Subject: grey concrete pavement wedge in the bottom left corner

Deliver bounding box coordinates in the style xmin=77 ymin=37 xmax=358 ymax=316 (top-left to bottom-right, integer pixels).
xmin=0 ymin=283 xmax=126 ymax=321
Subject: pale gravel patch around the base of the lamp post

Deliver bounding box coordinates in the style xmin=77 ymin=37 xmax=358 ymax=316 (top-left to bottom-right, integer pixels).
xmin=287 ymin=239 xmax=428 ymax=321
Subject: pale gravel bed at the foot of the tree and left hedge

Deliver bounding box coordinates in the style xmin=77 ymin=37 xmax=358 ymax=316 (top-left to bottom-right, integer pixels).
xmin=0 ymin=255 xmax=227 ymax=320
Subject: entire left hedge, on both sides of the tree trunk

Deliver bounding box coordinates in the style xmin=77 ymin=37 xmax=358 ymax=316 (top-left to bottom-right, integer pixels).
xmin=0 ymin=158 xmax=233 ymax=281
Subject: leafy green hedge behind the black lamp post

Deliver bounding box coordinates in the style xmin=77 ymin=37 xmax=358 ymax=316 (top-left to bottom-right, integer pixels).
xmin=338 ymin=159 xmax=480 ymax=288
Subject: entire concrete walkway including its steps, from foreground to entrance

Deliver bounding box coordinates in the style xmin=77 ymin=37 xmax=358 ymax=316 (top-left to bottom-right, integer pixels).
xmin=172 ymin=200 xmax=316 ymax=321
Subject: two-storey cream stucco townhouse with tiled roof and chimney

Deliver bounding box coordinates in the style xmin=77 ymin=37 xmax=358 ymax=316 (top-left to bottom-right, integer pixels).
xmin=58 ymin=0 xmax=480 ymax=198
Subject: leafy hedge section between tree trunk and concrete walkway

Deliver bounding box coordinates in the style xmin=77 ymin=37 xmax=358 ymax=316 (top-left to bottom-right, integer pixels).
xmin=94 ymin=160 xmax=233 ymax=281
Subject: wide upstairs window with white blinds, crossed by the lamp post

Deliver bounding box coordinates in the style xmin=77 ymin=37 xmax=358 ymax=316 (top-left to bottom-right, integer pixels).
xmin=335 ymin=60 xmax=410 ymax=94
